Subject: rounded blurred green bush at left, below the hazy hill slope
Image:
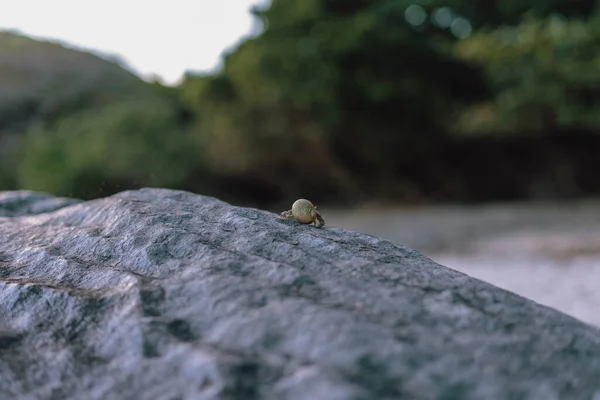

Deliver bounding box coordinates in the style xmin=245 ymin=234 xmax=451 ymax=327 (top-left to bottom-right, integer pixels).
xmin=18 ymin=100 xmax=197 ymax=199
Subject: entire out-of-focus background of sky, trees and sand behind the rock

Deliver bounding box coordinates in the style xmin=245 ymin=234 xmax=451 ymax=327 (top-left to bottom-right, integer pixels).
xmin=0 ymin=0 xmax=600 ymax=325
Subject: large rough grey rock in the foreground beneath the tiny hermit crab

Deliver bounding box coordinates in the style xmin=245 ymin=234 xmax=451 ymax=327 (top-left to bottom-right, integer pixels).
xmin=0 ymin=189 xmax=600 ymax=400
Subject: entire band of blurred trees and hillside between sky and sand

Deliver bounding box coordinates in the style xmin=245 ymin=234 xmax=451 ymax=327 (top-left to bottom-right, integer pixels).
xmin=0 ymin=0 xmax=600 ymax=205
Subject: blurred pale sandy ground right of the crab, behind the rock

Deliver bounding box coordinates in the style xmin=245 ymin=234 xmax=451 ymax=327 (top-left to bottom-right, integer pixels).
xmin=326 ymin=200 xmax=600 ymax=326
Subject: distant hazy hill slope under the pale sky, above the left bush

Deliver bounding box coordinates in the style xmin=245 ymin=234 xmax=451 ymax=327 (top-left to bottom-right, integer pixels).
xmin=0 ymin=31 xmax=154 ymax=136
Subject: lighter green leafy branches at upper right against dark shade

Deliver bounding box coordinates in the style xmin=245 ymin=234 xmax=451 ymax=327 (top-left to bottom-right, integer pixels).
xmin=456 ymin=9 xmax=600 ymax=135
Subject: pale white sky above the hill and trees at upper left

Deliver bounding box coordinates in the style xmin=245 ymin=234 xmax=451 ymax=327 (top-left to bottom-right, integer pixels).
xmin=0 ymin=0 xmax=268 ymax=83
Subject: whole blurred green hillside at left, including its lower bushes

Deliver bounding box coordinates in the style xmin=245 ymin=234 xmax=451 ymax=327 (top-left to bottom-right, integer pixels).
xmin=0 ymin=32 xmax=200 ymax=198
